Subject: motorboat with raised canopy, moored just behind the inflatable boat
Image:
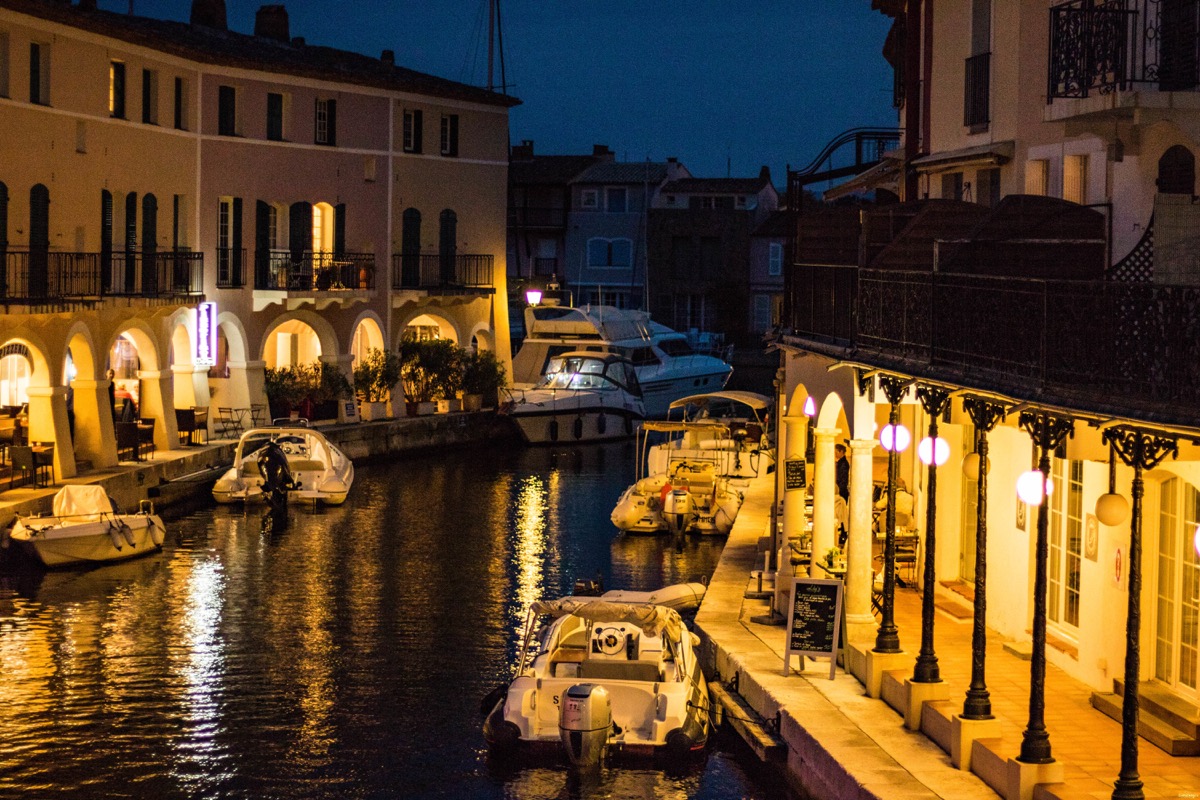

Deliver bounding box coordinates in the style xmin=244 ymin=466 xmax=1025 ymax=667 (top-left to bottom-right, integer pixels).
xmin=638 ymin=391 xmax=774 ymax=479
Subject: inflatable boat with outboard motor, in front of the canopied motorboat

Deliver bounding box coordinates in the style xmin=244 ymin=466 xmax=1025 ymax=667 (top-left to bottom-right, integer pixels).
xmin=610 ymin=458 xmax=745 ymax=536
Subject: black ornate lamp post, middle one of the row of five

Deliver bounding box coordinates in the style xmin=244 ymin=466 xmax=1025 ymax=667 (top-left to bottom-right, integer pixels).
xmin=962 ymin=397 xmax=1004 ymax=720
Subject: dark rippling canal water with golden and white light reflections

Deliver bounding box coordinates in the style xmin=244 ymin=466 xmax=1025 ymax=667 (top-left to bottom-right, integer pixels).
xmin=0 ymin=443 xmax=790 ymax=800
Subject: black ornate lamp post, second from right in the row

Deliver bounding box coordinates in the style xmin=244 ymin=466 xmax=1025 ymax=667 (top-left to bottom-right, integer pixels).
xmin=1016 ymin=409 xmax=1075 ymax=764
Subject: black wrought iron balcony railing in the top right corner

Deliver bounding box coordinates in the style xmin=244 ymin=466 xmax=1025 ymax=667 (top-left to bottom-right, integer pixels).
xmin=1046 ymin=0 xmax=1200 ymax=102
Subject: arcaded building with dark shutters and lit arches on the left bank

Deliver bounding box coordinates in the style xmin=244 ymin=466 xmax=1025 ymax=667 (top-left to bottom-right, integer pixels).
xmin=0 ymin=0 xmax=516 ymax=477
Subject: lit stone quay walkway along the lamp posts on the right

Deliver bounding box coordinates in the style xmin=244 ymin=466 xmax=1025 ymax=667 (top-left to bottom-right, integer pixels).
xmin=696 ymin=477 xmax=1200 ymax=800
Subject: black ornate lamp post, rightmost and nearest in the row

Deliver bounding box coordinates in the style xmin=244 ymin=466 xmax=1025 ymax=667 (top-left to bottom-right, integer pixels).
xmin=1102 ymin=428 xmax=1178 ymax=800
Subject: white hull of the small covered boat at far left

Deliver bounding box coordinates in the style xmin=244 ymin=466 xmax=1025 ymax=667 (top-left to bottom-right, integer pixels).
xmin=11 ymin=515 xmax=166 ymax=567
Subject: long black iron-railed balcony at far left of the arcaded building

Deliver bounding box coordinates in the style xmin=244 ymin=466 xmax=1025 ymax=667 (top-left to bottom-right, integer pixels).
xmin=0 ymin=249 xmax=204 ymax=306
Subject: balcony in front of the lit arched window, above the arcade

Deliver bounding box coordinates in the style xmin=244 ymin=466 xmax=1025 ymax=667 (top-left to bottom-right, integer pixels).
xmin=254 ymin=249 xmax=374 ymax=311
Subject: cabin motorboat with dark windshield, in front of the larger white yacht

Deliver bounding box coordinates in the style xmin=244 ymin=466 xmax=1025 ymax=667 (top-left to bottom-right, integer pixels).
xmin=500 ymin=351 xmax=646 ymax=444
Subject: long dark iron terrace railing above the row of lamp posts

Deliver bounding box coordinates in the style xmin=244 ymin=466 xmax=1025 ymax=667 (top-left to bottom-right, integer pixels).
xmin=787 ymin=265 xmax=1200 ymax=425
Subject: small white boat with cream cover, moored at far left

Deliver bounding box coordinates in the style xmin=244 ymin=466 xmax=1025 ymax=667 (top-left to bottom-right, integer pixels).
xmin=8 ymin=485 xmax=167 ymax=567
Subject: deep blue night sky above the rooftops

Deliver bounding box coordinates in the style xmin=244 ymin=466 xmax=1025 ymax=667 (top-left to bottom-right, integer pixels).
xmin=100 ymin=0 xmax=896 ymax=188
